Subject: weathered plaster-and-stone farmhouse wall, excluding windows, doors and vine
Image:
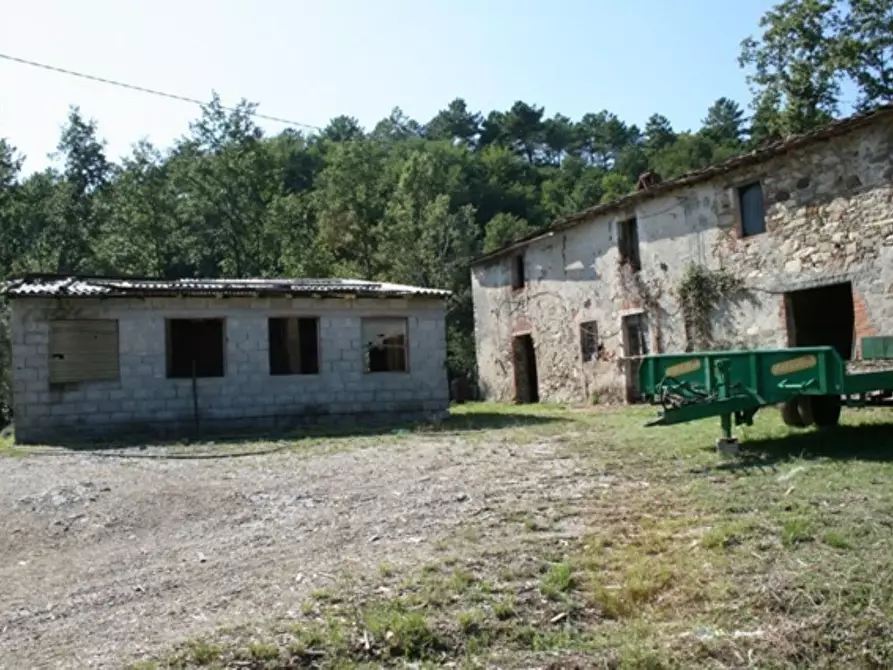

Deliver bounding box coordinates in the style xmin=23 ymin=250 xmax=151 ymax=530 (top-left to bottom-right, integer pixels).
xmin=472 ymin=114 xmax=893 ymax=402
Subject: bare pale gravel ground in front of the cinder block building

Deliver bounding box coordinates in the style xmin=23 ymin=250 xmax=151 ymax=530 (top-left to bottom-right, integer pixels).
xmin=0 ymin=435 xmax=587 ymax=668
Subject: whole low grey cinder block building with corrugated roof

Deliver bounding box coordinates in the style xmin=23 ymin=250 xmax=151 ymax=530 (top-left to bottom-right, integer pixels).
xmin=5 ymin=276 xmax=449 ymax=443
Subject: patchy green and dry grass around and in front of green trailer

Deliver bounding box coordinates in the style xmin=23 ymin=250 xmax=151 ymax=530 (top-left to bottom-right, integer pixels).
xmin=136 ymin=406 xmax=893 ymax=668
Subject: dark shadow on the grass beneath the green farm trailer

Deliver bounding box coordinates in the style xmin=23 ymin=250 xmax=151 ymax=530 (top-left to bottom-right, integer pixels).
xmin=720 ymin=422 xmax=893 ymax=469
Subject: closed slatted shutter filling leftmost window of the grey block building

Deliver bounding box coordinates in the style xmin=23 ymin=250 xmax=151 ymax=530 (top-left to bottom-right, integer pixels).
xmin=50 ymin=319 xmax=118 ymax=384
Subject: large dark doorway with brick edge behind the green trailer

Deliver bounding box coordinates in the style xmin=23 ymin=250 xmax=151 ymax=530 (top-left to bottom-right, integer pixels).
xmin=785 ymin=282 xmax=856 ymax=361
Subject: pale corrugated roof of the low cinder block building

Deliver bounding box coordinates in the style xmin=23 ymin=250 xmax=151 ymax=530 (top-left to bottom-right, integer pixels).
xmin=0 ymin=275 xmax=451 ymax=298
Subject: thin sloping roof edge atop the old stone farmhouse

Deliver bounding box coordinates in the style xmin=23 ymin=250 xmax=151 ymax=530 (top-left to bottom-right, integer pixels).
xmin=471 ymin=104 xmax=893 ymax=265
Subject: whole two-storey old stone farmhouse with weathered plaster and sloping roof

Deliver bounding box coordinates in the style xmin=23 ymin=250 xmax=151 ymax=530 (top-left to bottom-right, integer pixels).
xmin=472 ymin=106 xmax=893 ymax=402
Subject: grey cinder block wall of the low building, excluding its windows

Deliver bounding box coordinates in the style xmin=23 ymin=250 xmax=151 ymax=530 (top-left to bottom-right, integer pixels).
xmin=12 ymin=298 xmax=449 ymax=443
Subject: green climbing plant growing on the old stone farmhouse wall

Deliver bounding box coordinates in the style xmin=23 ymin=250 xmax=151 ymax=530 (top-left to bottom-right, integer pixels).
xmin=676 ymin=263 xmax=744 ymax=349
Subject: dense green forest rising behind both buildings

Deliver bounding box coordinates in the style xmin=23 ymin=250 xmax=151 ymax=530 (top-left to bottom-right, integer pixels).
xmin=0 ymin=0 xmax=893 ymax=426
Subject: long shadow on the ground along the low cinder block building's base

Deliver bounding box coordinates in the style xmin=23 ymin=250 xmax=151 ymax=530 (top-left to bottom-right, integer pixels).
xmin=10 ymin=412 xmax=570 ymax=457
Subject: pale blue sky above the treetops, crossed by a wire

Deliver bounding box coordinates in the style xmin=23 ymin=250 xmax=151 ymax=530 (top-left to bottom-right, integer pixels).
xmin=0 ymin=0 xmax=775 ymax=173
